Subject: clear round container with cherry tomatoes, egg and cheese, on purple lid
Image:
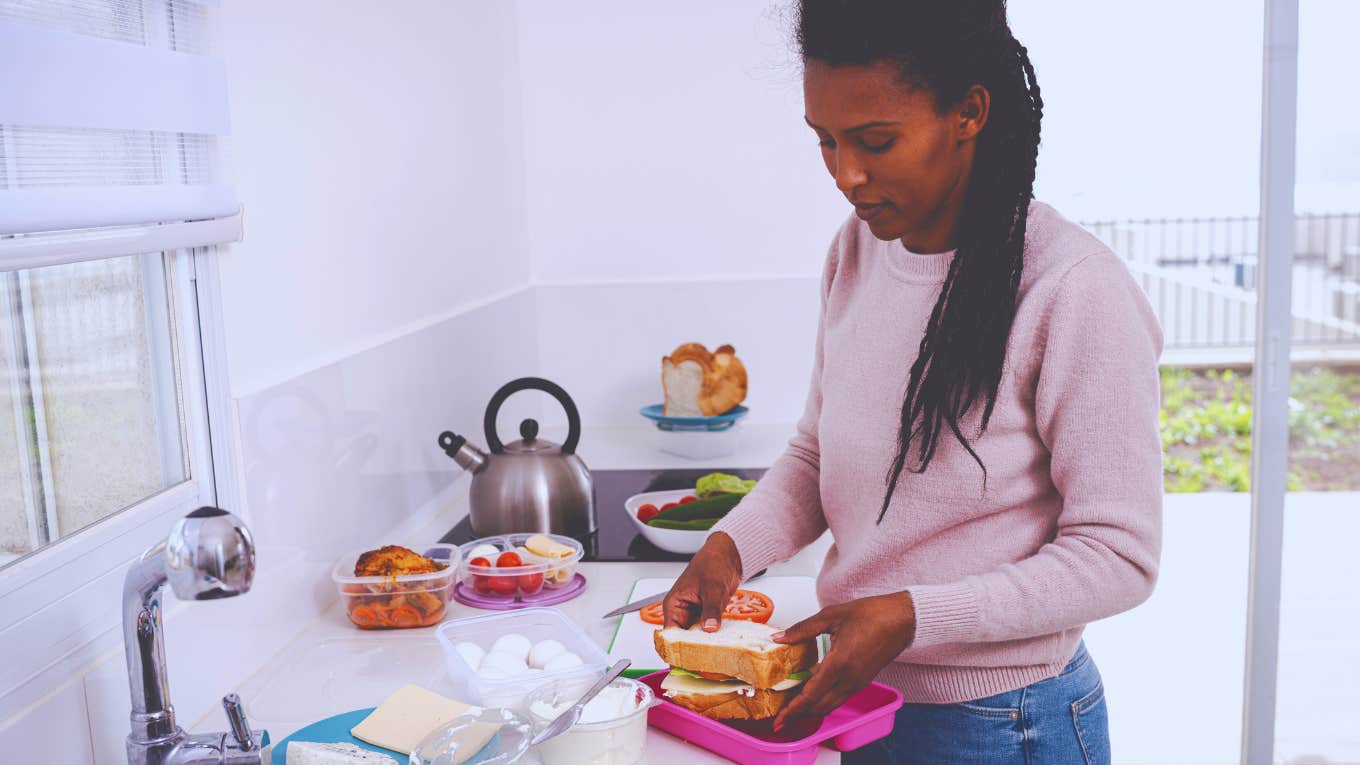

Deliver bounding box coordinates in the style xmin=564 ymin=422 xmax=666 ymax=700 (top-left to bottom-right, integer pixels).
xmin=458 ymin=534 xmax=585 ymax=600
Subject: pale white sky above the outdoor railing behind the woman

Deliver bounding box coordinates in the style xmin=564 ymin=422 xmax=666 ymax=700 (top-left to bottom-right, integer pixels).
xmin=1009 ymin=0 xmax=1360 ymax=221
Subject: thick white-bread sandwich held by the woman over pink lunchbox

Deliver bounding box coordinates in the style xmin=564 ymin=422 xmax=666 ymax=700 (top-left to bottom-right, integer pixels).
xmin=653 ymin=619 xmax=817 ymax=720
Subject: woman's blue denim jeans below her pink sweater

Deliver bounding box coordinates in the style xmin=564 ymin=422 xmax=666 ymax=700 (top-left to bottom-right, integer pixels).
xmin=840 ymin=642 xmax=1110 ymax=765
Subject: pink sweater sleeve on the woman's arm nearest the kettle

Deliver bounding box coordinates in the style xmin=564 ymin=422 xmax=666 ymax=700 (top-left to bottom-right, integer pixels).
xmin=713 ymin=230 xmax=845 ymax=580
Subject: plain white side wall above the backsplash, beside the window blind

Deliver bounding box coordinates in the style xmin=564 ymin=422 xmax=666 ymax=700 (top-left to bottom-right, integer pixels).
xmin=222 ymin=0 xmax=529 ymax=396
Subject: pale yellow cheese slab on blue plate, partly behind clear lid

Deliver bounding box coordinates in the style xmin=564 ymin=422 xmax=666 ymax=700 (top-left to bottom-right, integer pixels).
xmin=350 ymin=685 xmax=499 ymax=764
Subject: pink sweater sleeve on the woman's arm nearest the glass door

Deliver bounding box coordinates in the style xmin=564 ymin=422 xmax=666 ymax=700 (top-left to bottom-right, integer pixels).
xmin=907 ymin=252 xmax=1163 ymax=648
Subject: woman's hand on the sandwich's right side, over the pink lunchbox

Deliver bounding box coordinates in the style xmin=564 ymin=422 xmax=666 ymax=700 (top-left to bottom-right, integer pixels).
xmin=772 ymin=592 xmax=917 ymax=731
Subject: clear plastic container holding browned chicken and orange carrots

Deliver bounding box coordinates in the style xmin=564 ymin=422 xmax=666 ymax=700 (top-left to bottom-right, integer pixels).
xmin=330 ymin=544 xmax=457 ymax=629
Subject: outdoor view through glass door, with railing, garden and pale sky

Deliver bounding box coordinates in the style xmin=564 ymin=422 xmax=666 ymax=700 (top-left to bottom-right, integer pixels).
xmin=1010 ymin=0 xmax=1360 ymax=765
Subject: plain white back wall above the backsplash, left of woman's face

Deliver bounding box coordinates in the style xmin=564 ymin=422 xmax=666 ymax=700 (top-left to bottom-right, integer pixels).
xmin=515 ymin=0 xmax=849 ymax=283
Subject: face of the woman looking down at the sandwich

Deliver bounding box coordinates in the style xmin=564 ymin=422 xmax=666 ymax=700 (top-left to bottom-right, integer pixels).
xmin=802 ymin=60 xmax=987 ymax=252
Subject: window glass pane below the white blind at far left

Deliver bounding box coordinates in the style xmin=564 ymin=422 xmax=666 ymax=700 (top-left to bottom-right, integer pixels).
xmin=0 ymin=253 xmax=191 ymax=565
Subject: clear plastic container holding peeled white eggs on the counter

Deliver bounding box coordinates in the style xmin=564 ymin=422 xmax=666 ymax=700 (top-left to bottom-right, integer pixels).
xmin=435 ymin=608 xmax=609 ymax=711
